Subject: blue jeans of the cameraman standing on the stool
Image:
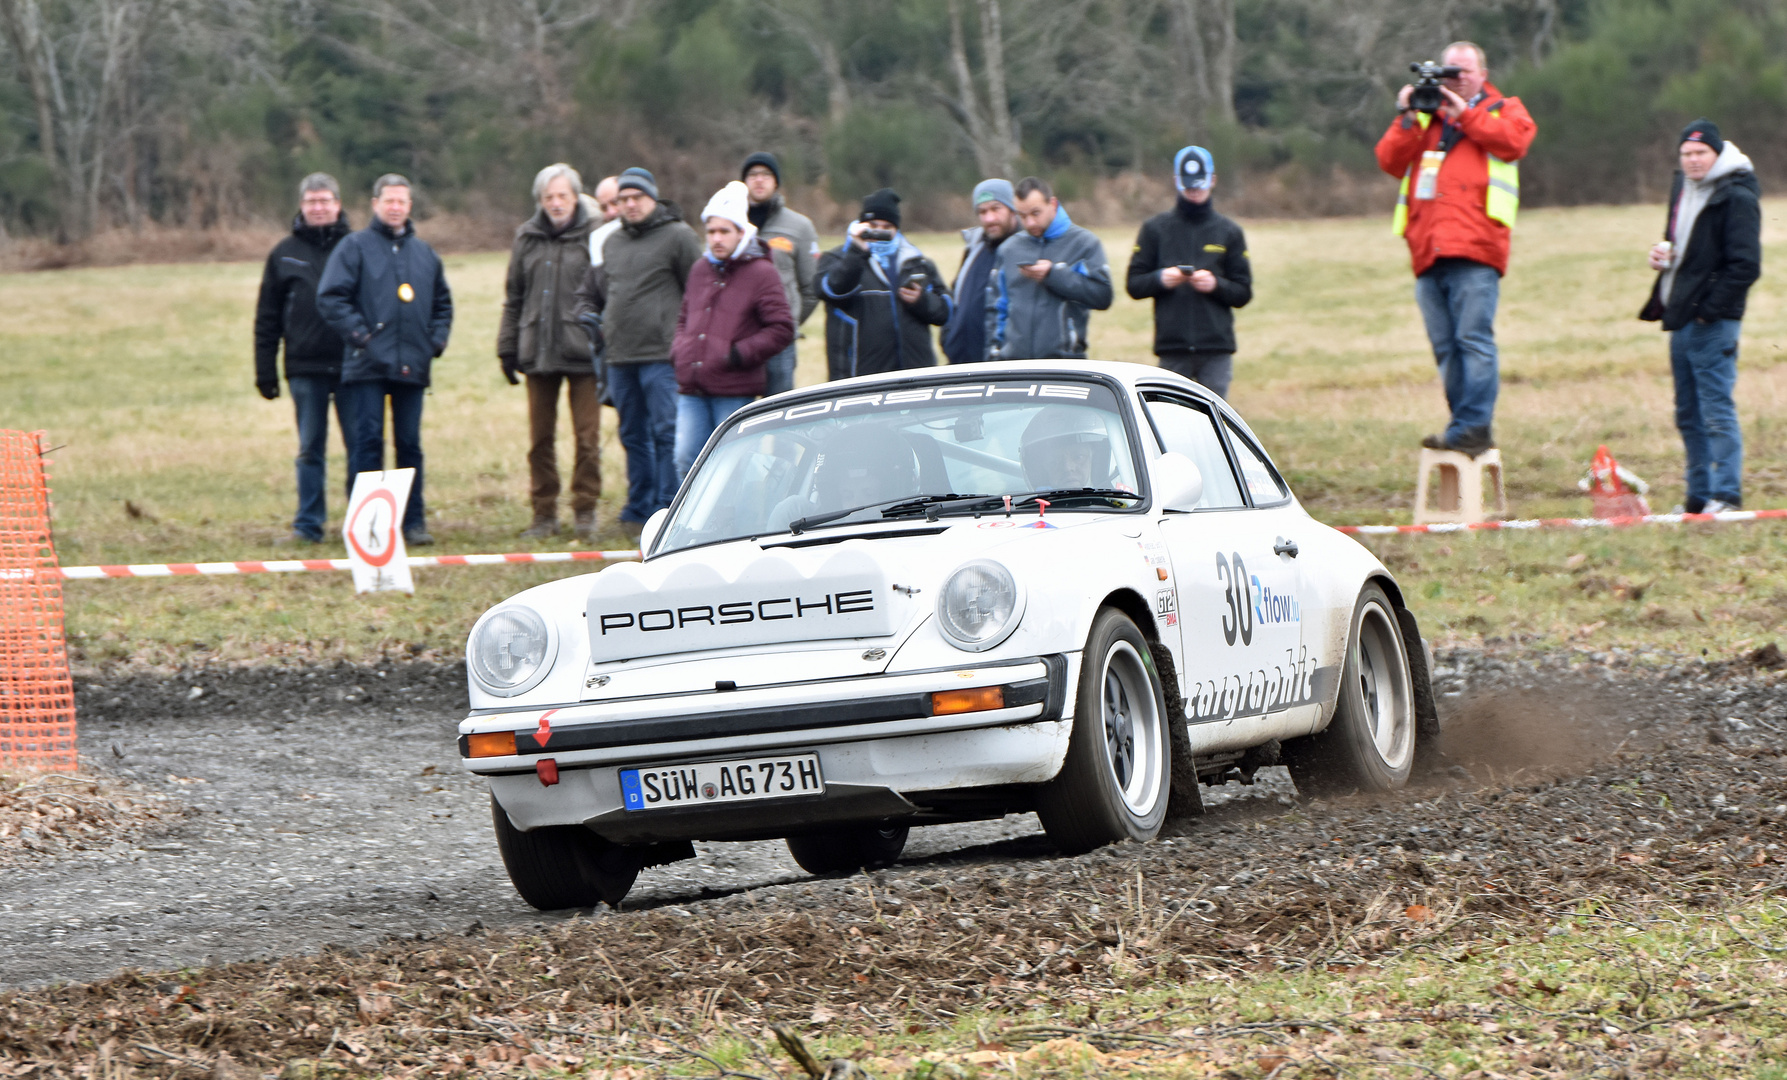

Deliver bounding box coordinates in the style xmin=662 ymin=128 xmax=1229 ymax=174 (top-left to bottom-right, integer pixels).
xmin=1415 ymin=259 xmax=1501 ymax=442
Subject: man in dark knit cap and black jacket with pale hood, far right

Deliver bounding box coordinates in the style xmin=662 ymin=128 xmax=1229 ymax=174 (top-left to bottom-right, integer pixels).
xmin=1639 ymin=118 xmax=1762 ymax=513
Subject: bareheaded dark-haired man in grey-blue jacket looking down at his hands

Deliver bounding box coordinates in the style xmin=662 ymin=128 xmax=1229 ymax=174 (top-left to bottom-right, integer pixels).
xmin=986 ymin=177 xmax=1112 ymax=359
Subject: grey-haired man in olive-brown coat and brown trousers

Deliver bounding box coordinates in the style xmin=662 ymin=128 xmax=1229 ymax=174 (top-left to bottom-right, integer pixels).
xmin=497 ymin=163 xmax=602 ymax=540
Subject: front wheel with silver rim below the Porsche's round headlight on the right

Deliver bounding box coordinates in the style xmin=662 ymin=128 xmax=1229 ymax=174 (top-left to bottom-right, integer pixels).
xmin=1036 ymin=608 xmax=1172 ymax=855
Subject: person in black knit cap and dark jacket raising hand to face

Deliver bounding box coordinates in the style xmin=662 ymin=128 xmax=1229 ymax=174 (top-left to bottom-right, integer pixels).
xmin=818 ymin=188 xmax=954 ymax=375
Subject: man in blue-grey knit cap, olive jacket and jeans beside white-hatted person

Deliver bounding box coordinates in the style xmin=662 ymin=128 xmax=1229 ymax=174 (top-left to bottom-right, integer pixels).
xmin=574 ymin=168 xmax=701 ymax=531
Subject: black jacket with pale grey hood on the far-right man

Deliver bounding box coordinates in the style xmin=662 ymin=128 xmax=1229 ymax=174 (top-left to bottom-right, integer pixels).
xmin=1639 ymin=143 xmax=1762 ymax=331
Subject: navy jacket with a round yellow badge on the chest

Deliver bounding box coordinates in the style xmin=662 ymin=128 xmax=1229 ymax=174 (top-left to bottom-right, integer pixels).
xmin=316 ymin=218 xmax=452 ymax=386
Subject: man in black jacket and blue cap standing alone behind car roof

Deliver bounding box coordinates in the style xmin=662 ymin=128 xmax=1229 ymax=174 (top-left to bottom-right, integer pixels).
xmin=1129 ymin=147 xmax=1253 ymax=397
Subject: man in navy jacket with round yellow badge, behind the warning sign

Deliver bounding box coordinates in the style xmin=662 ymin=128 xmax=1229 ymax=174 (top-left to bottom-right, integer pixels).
xmin=316 ymin=173 xmax=452 ymax=545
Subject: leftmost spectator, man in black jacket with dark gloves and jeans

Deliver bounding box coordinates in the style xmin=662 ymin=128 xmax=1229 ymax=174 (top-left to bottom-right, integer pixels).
xmin=254 ymin=172 xmax=354 ymax=544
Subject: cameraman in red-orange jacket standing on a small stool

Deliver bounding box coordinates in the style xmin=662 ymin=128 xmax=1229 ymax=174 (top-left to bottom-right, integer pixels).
xmin=1378 ymin=41 xmax=1537 ymax=456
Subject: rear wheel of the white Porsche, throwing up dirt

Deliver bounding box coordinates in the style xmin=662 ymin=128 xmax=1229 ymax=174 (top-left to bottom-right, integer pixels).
xmin=1283 ymin=585 xmax=1417 ymax=797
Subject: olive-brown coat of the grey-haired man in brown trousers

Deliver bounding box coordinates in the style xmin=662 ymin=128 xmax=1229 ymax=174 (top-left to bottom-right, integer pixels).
xmin=497 ymin=200 xmax=597 ymax=375
